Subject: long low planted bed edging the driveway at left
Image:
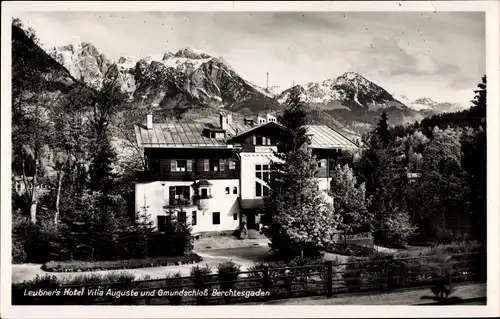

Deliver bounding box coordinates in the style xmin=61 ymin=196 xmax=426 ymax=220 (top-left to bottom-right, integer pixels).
xmin=42 ymin=253 xmax=203 ymax=272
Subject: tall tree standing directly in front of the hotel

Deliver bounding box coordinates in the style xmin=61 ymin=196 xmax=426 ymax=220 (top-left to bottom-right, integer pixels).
xmin=263 ymin=87 xmax=339 ymax=258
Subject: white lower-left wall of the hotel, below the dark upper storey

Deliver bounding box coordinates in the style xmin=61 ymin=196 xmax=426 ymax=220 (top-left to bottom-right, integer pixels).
xmin=135 ymin=179 xmax=240 ymax=233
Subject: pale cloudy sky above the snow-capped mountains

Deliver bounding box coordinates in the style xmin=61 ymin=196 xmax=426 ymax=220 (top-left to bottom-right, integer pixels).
xmin=15 ymin=12 xmax=486 ymax=105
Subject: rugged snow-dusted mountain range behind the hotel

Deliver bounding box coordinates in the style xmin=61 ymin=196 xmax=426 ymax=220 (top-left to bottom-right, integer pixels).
xmin=34 ymin=38 xmax=464 ymax=131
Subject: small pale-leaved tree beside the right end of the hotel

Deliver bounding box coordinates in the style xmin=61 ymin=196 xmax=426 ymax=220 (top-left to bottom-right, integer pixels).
xmin=330 ymin=164 xmax=373 ymax=232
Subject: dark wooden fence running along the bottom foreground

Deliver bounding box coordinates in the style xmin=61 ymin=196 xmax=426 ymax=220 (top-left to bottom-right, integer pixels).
xmin=12 ymin=253 xmax=486 ymax=305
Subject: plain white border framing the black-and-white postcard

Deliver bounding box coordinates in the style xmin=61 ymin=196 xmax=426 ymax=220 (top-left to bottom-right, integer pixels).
xmin=0 ymin=0 xmax=500 ymax=318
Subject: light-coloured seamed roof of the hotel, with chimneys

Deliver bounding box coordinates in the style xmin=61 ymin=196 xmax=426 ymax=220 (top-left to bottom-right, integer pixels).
xmin=135 ymin=121 xmax=358 ymax=149
